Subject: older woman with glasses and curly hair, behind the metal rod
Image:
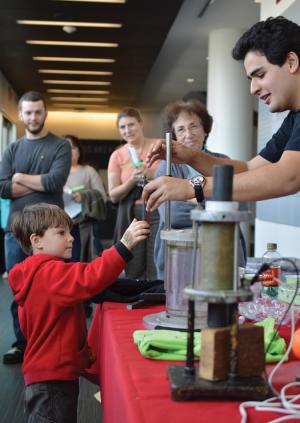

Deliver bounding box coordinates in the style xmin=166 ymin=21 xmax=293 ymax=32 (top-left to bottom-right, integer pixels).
xmin=154 ymin=100 xmax=245 ymax=279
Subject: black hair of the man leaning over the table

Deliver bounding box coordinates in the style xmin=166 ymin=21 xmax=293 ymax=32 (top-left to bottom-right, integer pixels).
xmin=232 ymin=16 xmax=300 ymax=66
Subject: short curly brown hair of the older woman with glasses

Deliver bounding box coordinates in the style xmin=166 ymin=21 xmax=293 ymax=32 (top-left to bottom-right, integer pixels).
xmin=163 ymin=100 xmax=213 ymax=135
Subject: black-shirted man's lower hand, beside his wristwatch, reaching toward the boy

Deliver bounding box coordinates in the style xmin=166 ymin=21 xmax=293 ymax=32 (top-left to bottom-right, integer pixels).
xmin=142 ymin=176 xmax=195 ymax=211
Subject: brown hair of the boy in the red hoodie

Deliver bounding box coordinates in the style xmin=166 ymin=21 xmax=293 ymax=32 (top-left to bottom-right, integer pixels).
xmin=11 ymin=203 xmax=73 ymax=255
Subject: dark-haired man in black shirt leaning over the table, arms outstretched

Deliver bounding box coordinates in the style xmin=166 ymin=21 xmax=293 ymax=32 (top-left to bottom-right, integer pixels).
xmin=143 ymin=16 xmax=300 ymax=210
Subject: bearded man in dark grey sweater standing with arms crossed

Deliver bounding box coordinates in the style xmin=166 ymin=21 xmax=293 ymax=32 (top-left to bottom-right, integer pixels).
xmin=0 ymin=91 xmax=71 ymax=364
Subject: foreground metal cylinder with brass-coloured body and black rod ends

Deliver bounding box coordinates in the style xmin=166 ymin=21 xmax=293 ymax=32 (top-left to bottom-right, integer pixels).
xmin=185 ymin=166 xmax=252 ymax=327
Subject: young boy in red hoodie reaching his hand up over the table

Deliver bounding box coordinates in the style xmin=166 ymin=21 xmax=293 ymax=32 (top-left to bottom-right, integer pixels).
xmin=9 ymin=203 xmax=149 ymax=423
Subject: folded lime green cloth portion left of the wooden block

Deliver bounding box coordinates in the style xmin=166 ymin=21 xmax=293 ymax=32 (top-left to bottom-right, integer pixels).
xmin=133 ymin=329 xmax=201 ymax=360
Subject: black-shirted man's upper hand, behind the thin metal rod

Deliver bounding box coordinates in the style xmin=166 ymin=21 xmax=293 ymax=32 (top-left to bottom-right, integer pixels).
xmin=146 ymin=140 xmax=196 ymax=166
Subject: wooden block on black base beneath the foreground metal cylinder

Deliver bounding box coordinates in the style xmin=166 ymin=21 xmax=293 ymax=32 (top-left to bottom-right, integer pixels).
xmin=200 ymin=325 xmax=265 ymax=381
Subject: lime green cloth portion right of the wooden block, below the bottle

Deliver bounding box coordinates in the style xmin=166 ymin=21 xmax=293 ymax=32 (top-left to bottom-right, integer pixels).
xmin=255 ymin=317 xmax=288 ymax=363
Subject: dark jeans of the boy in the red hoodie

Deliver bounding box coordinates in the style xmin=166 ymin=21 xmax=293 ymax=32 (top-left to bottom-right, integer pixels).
xmin=24 ymin=379 xmax=79 ymax=423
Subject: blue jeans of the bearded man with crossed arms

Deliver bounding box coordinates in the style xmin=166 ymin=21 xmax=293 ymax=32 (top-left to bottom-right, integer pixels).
xmin=4 ymin=232 xmax=27 ymax=350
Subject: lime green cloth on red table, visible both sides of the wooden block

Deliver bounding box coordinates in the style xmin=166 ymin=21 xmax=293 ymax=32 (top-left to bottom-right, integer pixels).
xmin=133 ymin=317 xmax=286 ymax=363
